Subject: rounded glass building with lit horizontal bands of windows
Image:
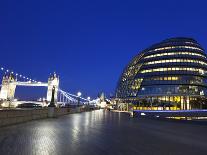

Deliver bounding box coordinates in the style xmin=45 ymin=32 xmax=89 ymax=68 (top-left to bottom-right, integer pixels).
xmin=116 ymin=38 xmax=207 ymax=110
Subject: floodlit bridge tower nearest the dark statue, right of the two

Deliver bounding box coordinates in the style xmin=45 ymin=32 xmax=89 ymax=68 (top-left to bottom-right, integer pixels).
xmin=47 ymin=73 xmax=59 ymax=103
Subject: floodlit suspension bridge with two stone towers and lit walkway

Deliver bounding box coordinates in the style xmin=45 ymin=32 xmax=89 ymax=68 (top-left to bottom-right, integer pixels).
xmin=0 ymin=73 xmax=89 ymax=105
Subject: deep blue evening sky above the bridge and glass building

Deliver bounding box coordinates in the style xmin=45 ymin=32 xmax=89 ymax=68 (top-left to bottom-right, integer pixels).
xmin=0 ymin=1 xmax=207 ymax=97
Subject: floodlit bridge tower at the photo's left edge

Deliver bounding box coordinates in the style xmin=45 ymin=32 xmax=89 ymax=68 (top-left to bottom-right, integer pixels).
xmin=0 ymin=73 xmax=16 ymax=101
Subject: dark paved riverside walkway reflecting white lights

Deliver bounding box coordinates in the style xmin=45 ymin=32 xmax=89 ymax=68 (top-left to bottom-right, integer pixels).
xmin=0 ymin=110 xmax=207 ymax=155
